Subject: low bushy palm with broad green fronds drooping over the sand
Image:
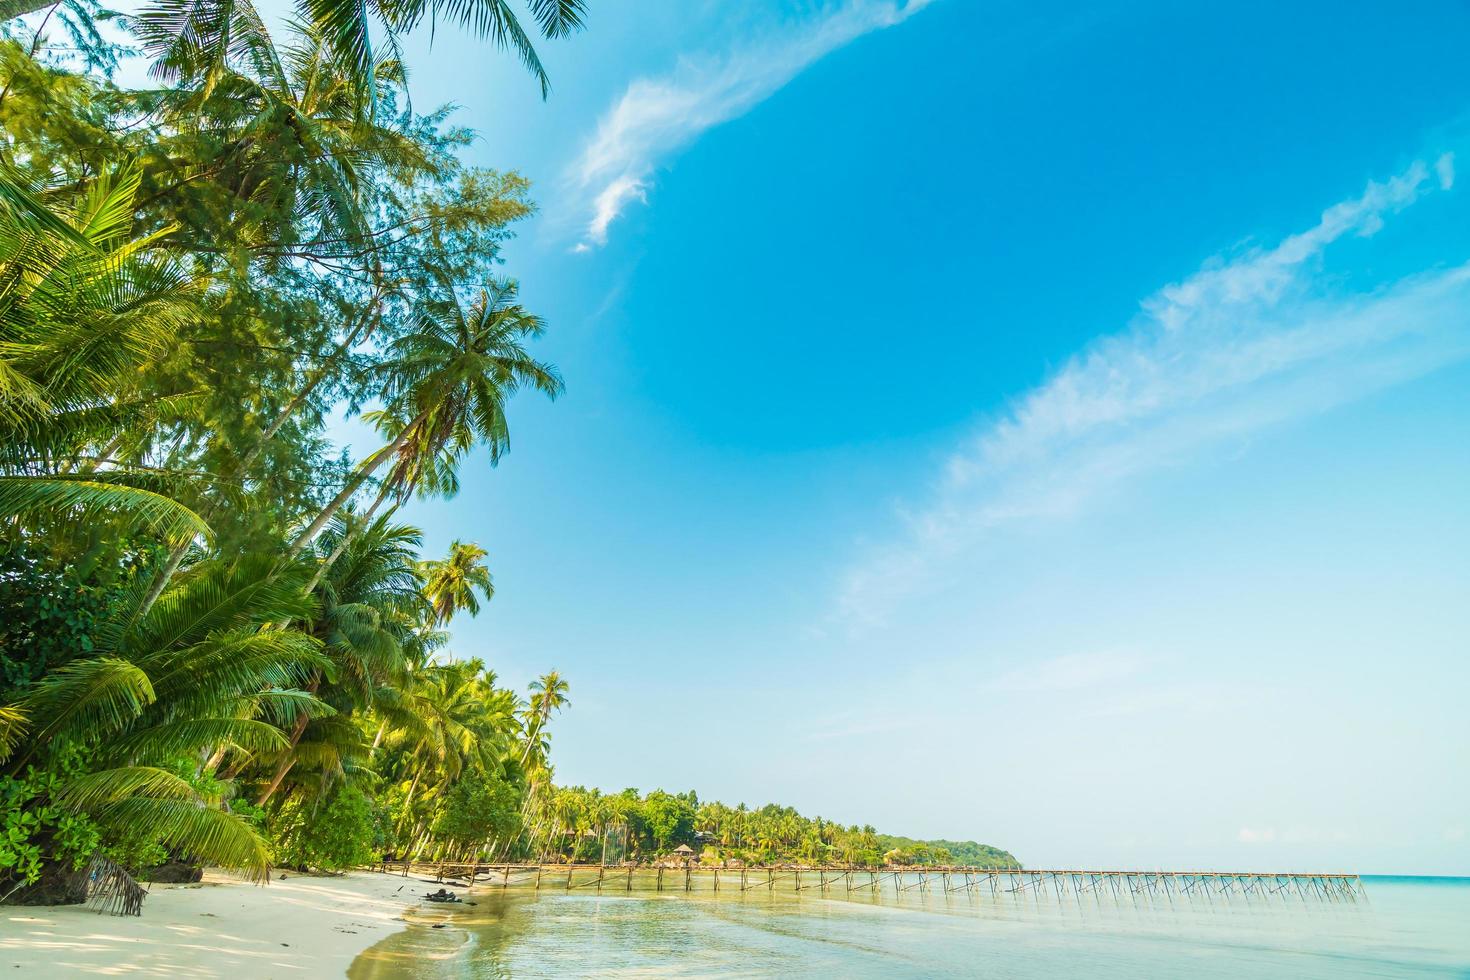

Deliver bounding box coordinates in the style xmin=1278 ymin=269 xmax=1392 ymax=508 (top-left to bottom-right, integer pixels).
xmin=0 ymin=557 xmax=331 ymax=877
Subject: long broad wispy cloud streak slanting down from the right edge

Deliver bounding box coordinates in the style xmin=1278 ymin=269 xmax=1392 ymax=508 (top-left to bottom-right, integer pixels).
xmin=839 ymin=154 xmax=1470 ymax=626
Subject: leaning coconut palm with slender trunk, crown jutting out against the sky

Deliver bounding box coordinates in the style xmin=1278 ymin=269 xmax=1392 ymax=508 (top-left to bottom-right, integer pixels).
xmin=288 ymin=282 xmax=562 ymax=557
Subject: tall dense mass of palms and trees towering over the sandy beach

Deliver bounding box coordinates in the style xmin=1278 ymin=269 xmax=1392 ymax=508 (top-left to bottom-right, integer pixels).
xmin=0 ymin=0 xmax=584 ymax=901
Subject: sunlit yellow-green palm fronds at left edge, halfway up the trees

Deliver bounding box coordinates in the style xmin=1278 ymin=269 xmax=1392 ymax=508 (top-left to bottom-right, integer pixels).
xmin=0 ymin=167 xmax=207 ymax=541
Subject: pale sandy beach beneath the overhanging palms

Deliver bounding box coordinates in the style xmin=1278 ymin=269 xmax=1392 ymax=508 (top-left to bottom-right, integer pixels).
xmin=0 ymin=871 xmax=437 ymax=979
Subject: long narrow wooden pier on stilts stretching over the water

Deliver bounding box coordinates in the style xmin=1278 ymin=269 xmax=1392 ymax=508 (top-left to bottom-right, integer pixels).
xmin=381 ymin=862 xmax=1366 ymax=902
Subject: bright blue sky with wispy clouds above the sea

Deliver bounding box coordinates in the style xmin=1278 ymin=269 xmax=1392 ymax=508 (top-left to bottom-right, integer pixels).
xmin=324 ymin=0 xmax=1470 ymax=873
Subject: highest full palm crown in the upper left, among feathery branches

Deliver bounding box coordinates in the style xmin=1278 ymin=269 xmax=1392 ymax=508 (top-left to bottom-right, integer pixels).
xmin=141 ymin=19 xmax=420 ymax=264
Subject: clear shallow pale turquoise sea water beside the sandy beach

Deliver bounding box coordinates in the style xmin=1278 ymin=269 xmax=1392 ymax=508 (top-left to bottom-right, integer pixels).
xmin=348 ymin=877 xmax=1470 ymax=980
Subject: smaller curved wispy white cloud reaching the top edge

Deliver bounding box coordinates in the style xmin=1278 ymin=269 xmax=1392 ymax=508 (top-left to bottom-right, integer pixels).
xmin=567 ymin=0 xmax=933 ymax=251
